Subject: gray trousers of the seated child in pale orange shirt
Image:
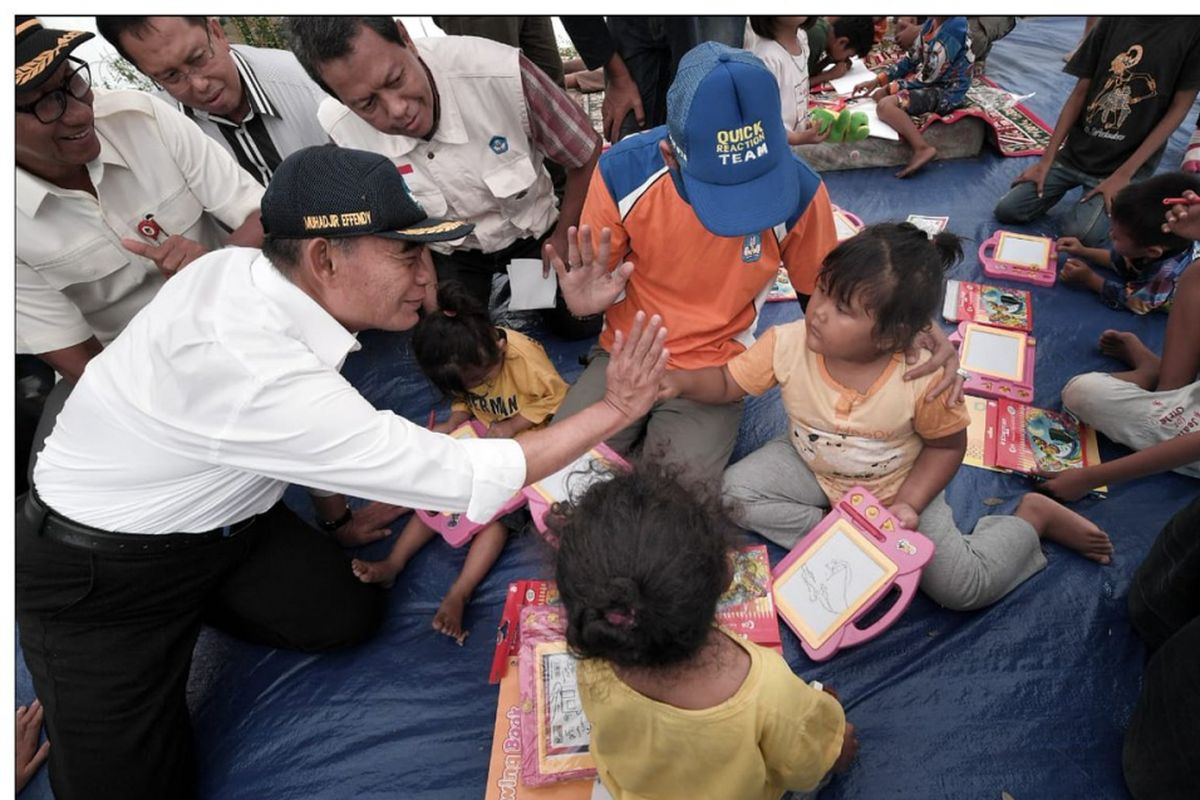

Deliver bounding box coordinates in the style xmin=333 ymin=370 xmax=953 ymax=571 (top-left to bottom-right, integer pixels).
xmin=721 ymin=434 xmax=1046 ymax=610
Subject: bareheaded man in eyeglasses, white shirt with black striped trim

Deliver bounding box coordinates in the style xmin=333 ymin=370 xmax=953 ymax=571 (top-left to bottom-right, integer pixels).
xmin=96 ymin=16 xmax=329 ymax=186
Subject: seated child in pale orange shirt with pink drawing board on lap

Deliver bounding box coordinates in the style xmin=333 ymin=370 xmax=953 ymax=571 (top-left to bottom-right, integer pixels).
xmin=667 ymin=223 xmax=1112 ymax=609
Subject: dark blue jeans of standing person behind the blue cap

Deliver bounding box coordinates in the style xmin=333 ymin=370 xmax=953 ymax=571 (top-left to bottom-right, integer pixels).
xmin=608 ymin=17 xmax=746 ymax=137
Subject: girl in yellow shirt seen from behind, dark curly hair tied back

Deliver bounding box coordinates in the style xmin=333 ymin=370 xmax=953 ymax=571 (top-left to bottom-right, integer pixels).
xmin=552 ymin=464 xmax=858 ymax=800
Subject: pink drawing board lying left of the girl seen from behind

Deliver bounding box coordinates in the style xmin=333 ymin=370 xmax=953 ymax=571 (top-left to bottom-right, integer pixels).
xmin=517 ymin=606 xmax=596 ymax=786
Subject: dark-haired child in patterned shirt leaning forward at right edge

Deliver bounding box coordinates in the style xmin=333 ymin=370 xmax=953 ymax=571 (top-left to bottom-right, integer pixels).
xmin=1058 ymin=173 xmax=1200 ymax=314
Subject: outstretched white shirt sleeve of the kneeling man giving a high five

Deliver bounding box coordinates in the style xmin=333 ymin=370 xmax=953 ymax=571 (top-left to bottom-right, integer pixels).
xmin=201 ymin=350 xmax=526 ymax=522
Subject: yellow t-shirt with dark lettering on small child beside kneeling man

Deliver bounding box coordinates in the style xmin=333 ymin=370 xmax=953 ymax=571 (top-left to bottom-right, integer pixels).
xmin=451 ymin=327 xmax=566 ymax=426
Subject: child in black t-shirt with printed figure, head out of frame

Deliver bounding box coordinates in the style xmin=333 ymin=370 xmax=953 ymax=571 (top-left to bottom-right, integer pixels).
xmin=995 ymin=17 xmax=1200 ymax=247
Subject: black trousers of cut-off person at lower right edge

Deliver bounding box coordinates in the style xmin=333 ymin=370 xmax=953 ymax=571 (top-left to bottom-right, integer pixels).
xmin=1121 ymin=498 xmax=1200 ymax=800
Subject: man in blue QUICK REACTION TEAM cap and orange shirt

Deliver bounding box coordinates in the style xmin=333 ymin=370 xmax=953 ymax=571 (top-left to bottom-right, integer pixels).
xmin=553 ymin=42 xmax=953 ymax=489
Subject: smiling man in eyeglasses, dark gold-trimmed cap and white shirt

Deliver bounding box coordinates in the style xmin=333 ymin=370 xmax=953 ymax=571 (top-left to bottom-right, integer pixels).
xmin=14 ymin=17 xmax=263 ymax=452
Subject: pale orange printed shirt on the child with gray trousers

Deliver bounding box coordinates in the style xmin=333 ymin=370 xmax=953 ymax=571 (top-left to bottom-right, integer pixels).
xmin=728 ymin=320 xmax=971 ymax=504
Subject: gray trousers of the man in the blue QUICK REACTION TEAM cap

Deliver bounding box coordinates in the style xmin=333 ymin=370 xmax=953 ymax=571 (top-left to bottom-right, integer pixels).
xmin=554 ymin=347 xmax=743 ymax=487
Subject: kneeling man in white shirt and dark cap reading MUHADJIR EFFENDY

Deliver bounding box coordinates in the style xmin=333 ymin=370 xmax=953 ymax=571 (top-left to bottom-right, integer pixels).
xmin=17 ymin=146 xmax=667 ymax=800
